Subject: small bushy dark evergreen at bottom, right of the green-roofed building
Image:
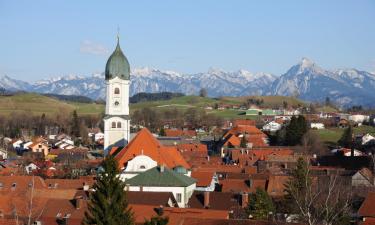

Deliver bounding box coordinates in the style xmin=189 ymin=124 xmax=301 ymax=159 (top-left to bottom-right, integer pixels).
xmin=246 ymin=187 xmax=275 ymax=219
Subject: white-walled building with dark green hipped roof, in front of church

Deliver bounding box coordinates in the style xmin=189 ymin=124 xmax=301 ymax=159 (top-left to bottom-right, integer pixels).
xmin=125 ymin=165 xmax=196 ymax=208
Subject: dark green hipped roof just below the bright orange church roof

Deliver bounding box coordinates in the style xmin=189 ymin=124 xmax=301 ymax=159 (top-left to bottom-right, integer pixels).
xmin=125 ymin=166 xmax=196 ymax=187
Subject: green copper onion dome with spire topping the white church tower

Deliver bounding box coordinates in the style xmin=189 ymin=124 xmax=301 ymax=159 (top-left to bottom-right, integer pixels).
xmin=105 ymin=40 xmax=130 ymax=80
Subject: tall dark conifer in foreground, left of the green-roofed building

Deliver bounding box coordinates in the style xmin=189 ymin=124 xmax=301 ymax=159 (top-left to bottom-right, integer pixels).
xmin=83 ymin=156 xmax=134 ymax=225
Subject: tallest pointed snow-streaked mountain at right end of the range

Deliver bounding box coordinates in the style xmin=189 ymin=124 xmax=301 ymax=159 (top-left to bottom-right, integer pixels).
xmin=271 ymin=58 xmax=375 ymax=106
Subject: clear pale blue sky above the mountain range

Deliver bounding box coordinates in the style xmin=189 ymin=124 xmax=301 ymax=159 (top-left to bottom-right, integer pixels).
xmin=0 ymin=0 xmax=375 ymax=82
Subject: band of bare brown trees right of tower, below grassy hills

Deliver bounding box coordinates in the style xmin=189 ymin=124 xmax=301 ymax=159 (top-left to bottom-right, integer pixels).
xmin=131 ymin=107 xmax=224 ymax=132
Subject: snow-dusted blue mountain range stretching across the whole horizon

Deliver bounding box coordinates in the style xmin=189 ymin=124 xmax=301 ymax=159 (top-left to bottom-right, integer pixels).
xmin=0 ymin=58 xmax=375 ymax=107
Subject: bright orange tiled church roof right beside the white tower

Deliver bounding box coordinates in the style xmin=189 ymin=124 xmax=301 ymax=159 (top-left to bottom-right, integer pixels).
xmin=115 ymin=128 xmax=190 ymax=169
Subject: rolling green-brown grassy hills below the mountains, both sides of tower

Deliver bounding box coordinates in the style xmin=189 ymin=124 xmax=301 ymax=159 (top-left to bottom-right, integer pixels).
xmin=0 ymin=94 xmax=312 ymax=118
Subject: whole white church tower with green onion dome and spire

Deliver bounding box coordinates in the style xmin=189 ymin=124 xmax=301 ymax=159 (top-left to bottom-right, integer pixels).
xmin=104 ymin=37 xmax=130 ymax=153
